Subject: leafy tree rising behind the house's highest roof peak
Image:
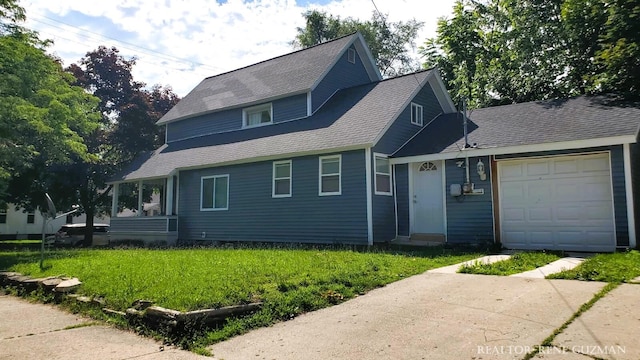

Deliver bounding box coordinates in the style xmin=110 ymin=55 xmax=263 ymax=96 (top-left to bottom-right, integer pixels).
xmin=291 ymin=10 xmax=423 ymax=77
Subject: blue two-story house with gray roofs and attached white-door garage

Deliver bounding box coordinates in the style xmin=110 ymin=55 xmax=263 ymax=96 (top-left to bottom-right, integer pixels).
xmin=111 ymin=33 xmax=640 ymax=251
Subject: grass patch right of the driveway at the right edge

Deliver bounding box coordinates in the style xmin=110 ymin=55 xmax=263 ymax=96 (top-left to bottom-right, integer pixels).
xmin=547 ymin=250 xmax=640 ymax=283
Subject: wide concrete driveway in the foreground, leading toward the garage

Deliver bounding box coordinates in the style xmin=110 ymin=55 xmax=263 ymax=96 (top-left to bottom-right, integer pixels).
xmin=210 ymin=272 xmax=640 ymax=360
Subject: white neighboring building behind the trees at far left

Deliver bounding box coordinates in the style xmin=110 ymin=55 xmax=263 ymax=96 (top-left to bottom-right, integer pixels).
xmin=0 ymin=204 xmax=110 ymax=240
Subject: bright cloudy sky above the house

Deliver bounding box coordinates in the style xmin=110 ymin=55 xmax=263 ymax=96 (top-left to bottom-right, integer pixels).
xmin=19 ymin=0 xmax=454 ymax=97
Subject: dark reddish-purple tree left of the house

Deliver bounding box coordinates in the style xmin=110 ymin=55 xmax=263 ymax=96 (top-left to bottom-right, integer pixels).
xmin=59 ymin=46 xmax=179 ymax=244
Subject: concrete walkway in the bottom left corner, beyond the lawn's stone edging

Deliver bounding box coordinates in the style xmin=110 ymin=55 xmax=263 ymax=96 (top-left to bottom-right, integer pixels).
xmin=0 ymin=290 xmax=210 ymax=360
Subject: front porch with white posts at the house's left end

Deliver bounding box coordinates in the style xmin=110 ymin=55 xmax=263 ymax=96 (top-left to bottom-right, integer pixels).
xmin=110 ymin=176 xmax=178 ymax=246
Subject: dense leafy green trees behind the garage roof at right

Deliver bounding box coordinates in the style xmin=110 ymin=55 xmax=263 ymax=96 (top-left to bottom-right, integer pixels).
xmin=420 ymin=0 xmax=640 ymax=107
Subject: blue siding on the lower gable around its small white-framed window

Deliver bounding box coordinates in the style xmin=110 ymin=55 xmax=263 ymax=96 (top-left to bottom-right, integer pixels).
xmin=373 ymin=87 xmax=443 ymax=154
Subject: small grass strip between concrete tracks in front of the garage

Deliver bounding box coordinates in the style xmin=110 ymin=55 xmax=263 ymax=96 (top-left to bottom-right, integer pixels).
xmin=459 ymin=252 xmax=560 ymax=276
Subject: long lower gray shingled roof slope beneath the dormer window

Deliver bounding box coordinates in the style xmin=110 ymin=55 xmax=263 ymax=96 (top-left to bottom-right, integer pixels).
xmin=113 ymin=70 xmax=433 ymax=181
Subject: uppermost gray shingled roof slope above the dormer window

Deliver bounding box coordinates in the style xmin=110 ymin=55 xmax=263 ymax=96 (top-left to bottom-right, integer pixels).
xmin=157 ymin=33 xmax=376 ymax=125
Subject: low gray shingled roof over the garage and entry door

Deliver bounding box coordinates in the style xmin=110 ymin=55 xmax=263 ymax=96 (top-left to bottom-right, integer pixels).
xmin=393 ymin=96 xmax=640 ymax=157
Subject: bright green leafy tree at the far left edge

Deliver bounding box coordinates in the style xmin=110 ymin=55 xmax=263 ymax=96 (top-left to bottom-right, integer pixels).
xmin=0 ymin=29 xmax=100 ymax=210
